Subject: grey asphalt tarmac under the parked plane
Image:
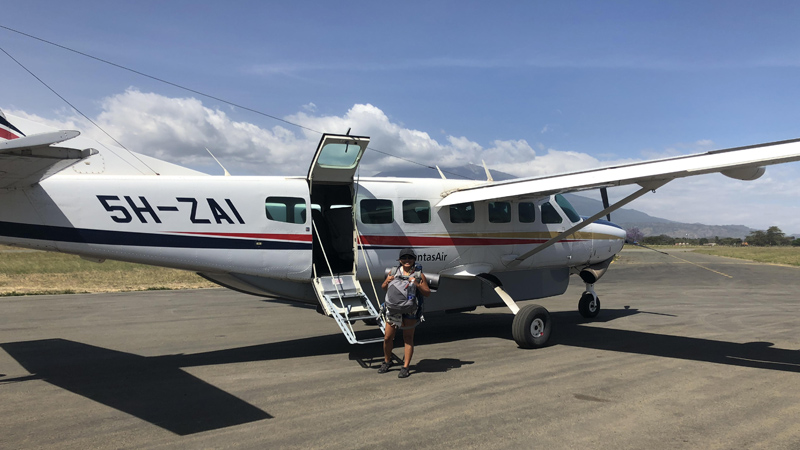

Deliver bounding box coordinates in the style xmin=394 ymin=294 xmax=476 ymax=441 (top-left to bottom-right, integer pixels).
xmin=0 ymin=249 xmax=800 ymax=449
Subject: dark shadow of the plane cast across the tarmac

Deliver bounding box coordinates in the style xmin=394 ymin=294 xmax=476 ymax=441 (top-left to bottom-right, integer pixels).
xmin=0 ymin=309 xmax=800 ymax=435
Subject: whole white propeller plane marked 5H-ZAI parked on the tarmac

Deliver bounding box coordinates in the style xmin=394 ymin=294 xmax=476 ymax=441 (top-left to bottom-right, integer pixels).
xmin=0 ymin=114 xmax=800 ymax=348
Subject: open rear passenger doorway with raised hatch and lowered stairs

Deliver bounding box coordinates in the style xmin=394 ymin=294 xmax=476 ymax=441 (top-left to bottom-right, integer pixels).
xmin=307 ymin=134 xmax=383 ymax=344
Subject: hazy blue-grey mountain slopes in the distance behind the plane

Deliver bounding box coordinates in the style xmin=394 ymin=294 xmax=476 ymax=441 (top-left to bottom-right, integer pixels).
xmin=375 ymin=164 xmax=754 ymax=239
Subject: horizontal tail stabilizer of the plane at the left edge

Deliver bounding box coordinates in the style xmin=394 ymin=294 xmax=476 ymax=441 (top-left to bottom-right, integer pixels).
xmin=0 ymin=131 xmax=98 ymax=189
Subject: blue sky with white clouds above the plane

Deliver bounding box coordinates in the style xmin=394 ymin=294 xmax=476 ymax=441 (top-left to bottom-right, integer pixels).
xmin=0 ymin=1 xmax=800 ymax=232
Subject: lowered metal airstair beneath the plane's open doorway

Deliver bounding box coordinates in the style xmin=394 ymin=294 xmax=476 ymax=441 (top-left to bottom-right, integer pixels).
xmin=314 ymin=274 xmax=385 ymax=344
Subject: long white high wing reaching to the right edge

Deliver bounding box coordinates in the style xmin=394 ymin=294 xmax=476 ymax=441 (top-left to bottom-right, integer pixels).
xmin=436 ymin=139 xmax=800 ymax=207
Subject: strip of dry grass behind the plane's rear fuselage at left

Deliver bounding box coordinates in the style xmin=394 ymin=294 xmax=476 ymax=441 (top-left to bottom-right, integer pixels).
xmin=0 ymin=246 xmax=216 ymax=296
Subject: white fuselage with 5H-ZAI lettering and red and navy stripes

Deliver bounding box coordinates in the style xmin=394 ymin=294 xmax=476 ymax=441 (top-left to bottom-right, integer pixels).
xmin=0 ymin=173 xmax=624 ymax=309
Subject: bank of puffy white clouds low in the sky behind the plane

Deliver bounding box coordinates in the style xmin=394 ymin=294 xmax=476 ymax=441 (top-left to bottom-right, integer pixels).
xmin=7 ymin=88 xmax=800 ymax=233
